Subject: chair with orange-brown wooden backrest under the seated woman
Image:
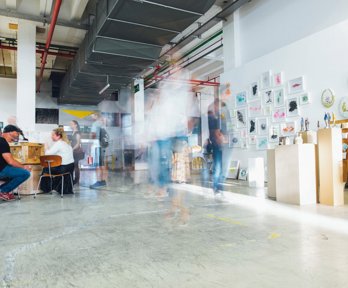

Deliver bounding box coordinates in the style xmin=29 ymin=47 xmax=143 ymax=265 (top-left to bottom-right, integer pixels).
xmin=34 ymin=155 xmax=74 ymax=198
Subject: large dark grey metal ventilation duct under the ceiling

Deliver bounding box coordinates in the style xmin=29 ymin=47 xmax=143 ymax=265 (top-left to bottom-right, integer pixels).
xmin=59 ymin=0 xmax=215 ymax=104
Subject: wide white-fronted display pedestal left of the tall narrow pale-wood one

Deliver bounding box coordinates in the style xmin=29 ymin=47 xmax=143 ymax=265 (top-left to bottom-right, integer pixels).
xmin=275 ymin=144 xmax=316 ymax=205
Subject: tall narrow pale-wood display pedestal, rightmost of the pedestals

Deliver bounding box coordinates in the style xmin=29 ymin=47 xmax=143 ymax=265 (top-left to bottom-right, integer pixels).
xmin=318 ymin=127 xmax=344 ymax=206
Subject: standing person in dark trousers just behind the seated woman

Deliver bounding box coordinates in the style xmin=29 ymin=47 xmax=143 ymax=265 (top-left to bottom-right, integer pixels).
xmin=70 ymin=120 xmax=85 ymax=185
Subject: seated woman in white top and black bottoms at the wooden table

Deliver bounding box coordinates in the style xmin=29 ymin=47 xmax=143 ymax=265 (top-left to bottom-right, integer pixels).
xmin=40 ymin=128 xmax=74 ymax=194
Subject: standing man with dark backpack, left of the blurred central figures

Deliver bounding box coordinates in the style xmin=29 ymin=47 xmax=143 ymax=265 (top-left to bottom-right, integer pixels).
xmin=89 ymin=112 xmax=108 ymax=189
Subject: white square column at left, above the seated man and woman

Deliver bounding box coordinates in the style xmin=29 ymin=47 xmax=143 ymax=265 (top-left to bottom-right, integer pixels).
xmin=16 ymin=20 xmax=36 ymax=131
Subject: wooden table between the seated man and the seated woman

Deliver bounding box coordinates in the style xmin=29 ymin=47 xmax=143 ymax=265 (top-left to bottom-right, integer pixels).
xmin=10 ymin=142 xmax=45 ymax=195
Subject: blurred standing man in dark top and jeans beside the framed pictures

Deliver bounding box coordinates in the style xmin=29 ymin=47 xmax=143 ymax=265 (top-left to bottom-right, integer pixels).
xmin=208 ymin=99 xmax=228 ymax=195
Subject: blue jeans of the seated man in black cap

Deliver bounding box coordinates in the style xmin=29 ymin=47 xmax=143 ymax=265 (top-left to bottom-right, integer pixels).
xmin=0 ymin=165 xmax=30 ymax=193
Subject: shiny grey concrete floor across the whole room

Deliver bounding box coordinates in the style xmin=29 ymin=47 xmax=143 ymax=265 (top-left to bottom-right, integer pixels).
xmin=0 ymin=173 xmax=348 ymax=288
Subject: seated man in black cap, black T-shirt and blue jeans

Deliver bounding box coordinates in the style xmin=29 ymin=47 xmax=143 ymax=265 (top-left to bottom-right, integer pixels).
xmin=0 ymin=125 xmax=30 ymax=201
